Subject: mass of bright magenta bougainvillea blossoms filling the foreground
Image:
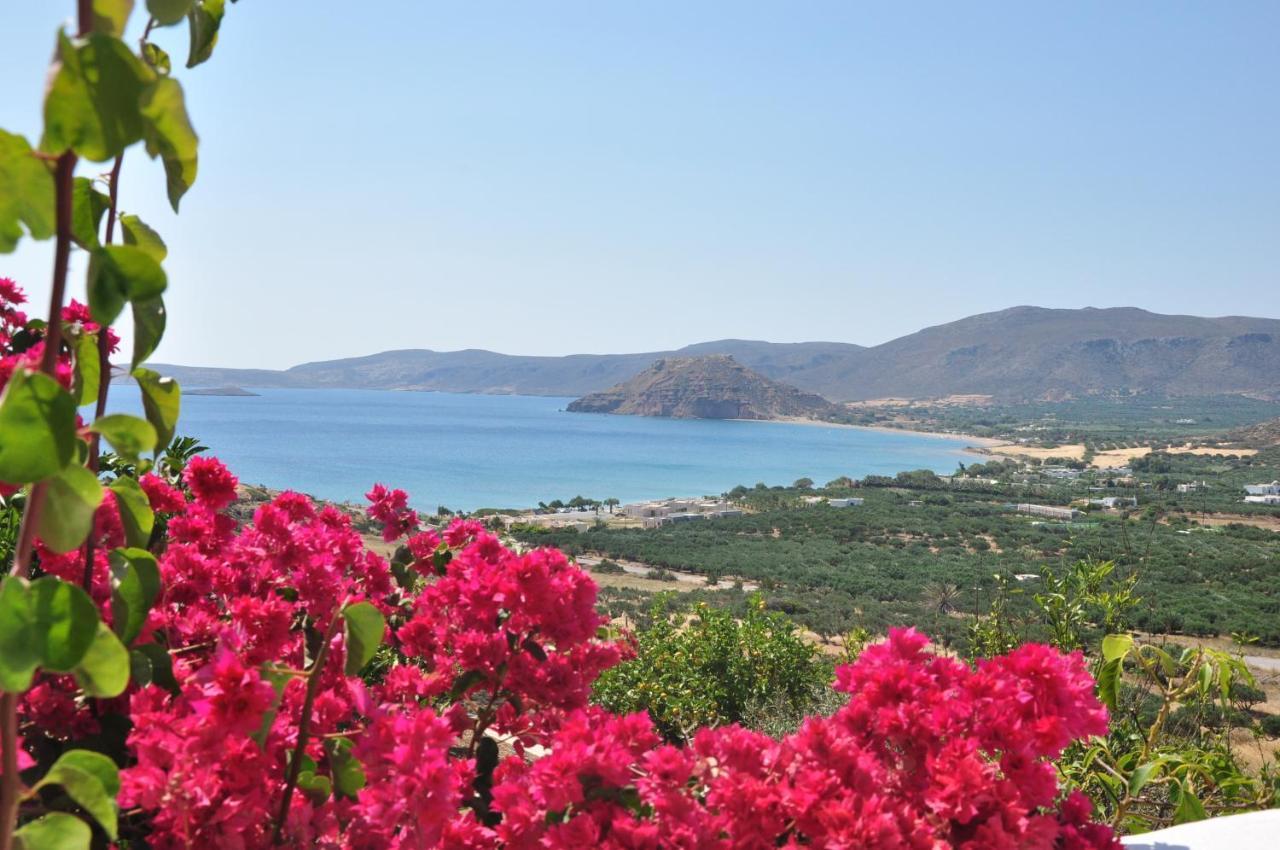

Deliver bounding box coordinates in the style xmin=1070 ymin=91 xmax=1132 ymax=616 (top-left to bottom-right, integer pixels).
xmin=10 ymin=448 xmax=1117 ymax=850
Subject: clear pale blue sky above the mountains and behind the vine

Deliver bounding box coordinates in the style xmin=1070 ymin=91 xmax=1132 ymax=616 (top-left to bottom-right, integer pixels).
xmin=0 ymin=0 xmax=1280 ymax=366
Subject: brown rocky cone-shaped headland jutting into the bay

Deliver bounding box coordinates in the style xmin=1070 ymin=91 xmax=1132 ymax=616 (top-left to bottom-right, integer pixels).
xmin=568 ymin=355 xmax=840 ymax=419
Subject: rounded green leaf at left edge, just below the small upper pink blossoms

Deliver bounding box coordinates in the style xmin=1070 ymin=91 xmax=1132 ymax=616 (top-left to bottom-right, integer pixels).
xmin=0 ymin=369 xmax=79 ymax=484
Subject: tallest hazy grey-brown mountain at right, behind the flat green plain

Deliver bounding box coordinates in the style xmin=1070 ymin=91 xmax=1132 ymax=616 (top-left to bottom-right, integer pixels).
xmin=792 ymin=307 xmax=1280 ymax=401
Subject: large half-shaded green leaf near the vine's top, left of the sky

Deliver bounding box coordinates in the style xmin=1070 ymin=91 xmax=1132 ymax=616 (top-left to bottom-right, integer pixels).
xmin=40 ymin=33 xmax=155 ymax=163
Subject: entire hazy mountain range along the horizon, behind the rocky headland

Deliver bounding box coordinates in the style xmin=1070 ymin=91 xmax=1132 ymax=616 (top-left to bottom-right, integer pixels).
xmin=155 ymin=307 xmax=1280 ymax=401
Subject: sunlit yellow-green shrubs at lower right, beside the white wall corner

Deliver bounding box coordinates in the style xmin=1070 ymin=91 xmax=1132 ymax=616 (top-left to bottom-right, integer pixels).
xmin=970 ymin=561 xmax=1280 ymax=832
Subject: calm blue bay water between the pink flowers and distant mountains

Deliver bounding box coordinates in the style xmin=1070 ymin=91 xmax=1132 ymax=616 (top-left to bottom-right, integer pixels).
xmin=149 ymin=389 xmax=973 ymax=509
